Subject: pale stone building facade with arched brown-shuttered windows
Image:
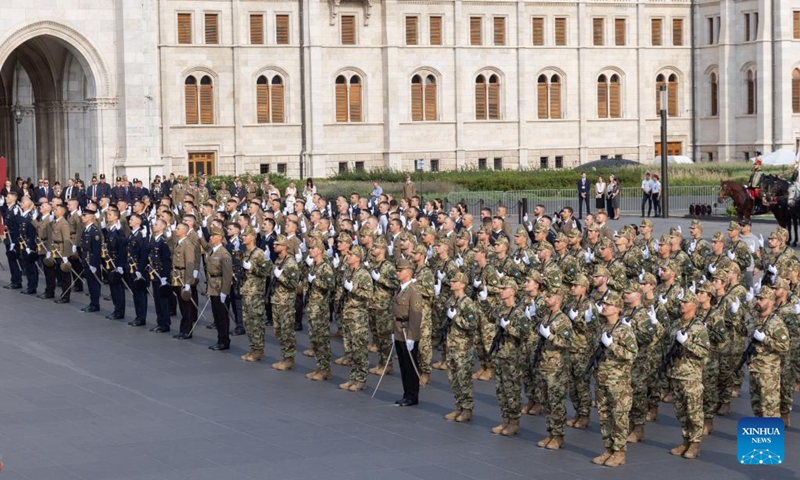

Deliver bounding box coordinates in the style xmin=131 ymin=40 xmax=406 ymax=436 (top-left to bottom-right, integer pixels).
xmin=0 ymin=0 xmax=800 ymax=185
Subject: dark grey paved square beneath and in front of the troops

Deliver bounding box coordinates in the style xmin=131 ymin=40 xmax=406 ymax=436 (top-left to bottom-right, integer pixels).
xmin=0 ymin=217 xmax=800 ymax=480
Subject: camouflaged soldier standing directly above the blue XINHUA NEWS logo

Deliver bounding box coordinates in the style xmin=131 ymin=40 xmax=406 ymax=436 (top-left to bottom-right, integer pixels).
xmin=749 ymin=287 xmax=789 ymax=417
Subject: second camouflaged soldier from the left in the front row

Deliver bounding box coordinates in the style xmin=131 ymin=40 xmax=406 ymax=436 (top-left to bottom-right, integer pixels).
xmin=270 ymin=235 xmax=300 ymax=371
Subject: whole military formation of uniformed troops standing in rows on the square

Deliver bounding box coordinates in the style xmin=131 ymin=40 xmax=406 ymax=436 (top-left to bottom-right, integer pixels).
xmin=0 ymin=173 xmax=800 ymax=467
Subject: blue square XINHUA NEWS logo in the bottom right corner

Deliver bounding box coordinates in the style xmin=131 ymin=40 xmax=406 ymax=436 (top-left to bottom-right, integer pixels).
xmin=736 ymin=417 xmax=784 ymax=465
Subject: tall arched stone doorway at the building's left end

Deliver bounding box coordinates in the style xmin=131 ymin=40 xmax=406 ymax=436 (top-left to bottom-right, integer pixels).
xmin=0 ymin=29 xmax=103 ymax=185
